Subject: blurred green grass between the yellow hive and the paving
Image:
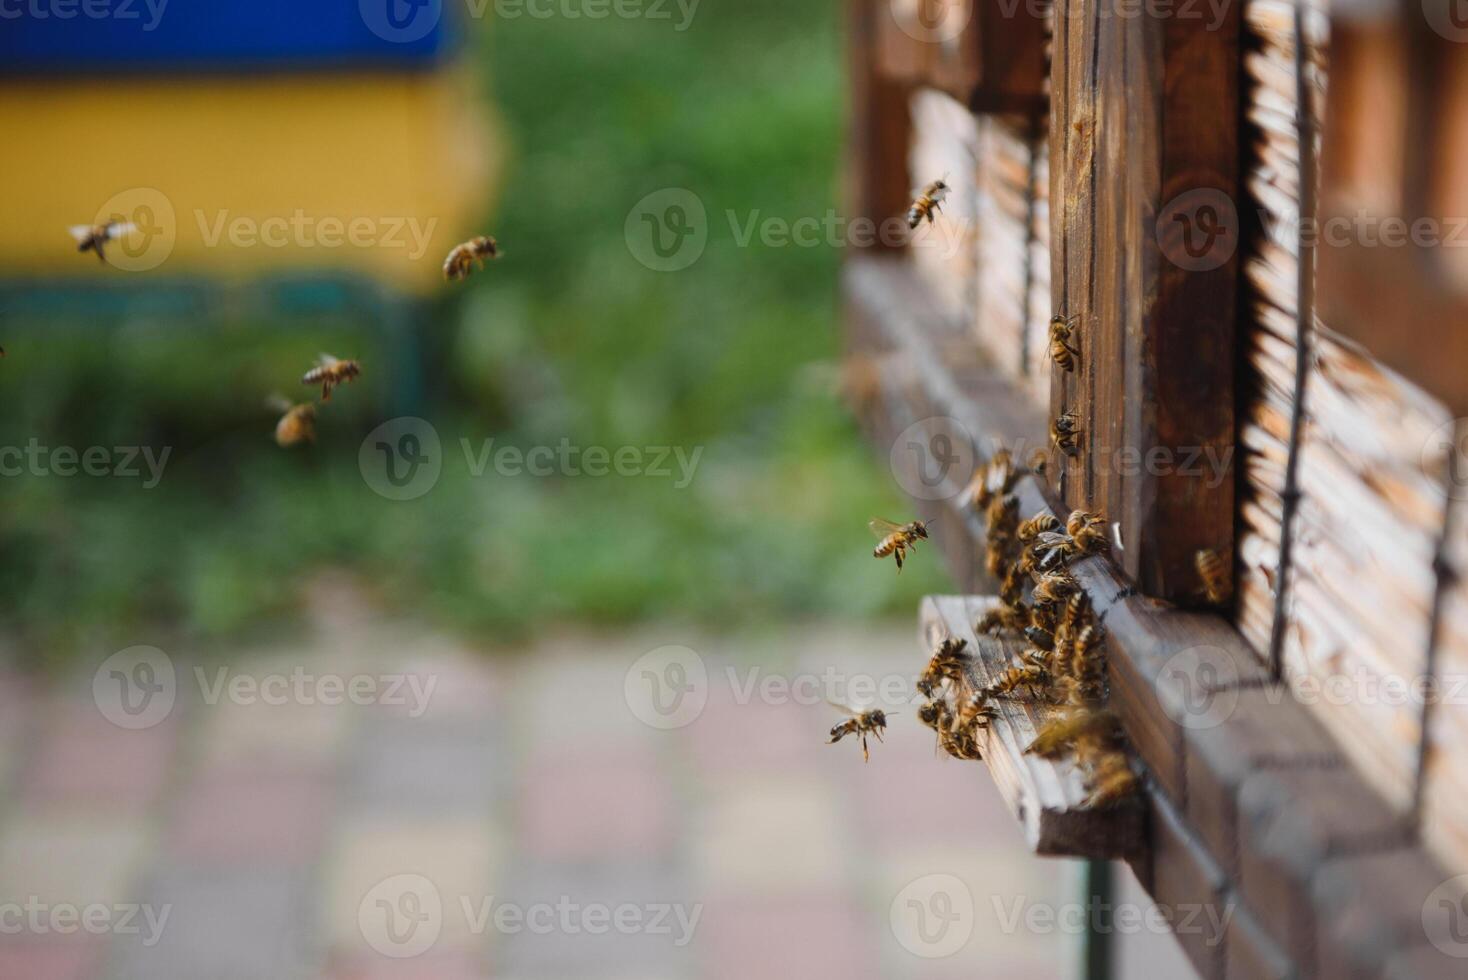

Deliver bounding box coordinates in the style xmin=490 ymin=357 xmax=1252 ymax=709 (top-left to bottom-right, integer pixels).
xmin=0 ymin=0 xmax=941 ymax=659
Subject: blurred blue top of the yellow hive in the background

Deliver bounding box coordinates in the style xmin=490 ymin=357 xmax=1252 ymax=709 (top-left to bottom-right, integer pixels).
xmin=0 ymin=0 xmax=462 ymax=75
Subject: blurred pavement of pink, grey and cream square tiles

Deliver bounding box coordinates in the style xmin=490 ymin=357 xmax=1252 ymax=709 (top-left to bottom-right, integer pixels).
xmin=0 ymin=592 xmax=1145 ymax=980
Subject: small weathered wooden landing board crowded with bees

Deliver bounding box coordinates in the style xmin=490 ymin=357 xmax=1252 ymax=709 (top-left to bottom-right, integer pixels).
xmin=919 ymin=596 xmax=1144 ymax=858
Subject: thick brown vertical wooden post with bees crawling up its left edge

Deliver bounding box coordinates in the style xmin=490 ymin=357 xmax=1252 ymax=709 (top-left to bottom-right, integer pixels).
xmin=1051 ymin=0 xmax=1242 ymax=601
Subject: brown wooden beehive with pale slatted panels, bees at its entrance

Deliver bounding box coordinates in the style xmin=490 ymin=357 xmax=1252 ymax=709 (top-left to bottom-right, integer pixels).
xmin=849 ymin=0 xmax=1468 ymax=976
